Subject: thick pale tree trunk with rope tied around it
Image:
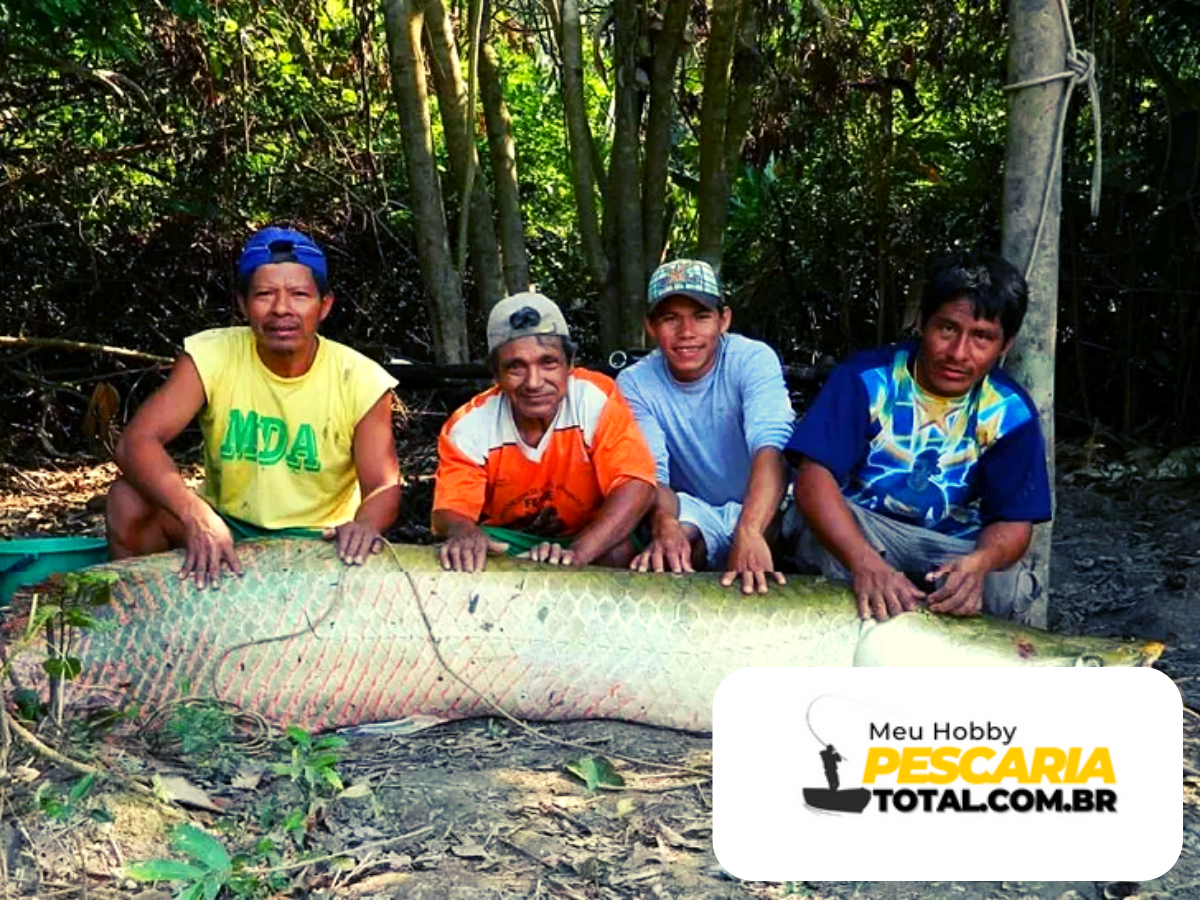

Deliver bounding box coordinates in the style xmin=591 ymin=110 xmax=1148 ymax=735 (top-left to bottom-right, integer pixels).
xmin=1002 ymin=0 xmax=1067 ymax=628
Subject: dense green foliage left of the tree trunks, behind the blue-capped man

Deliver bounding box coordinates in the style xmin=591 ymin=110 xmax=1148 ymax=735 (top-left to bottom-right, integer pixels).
xmin=0 ymin=0 xmax=410 ymax=340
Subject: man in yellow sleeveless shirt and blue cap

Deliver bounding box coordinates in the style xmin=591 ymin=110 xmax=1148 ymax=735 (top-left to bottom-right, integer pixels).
xmin=108 ymin=228 xmax=400 ymax=587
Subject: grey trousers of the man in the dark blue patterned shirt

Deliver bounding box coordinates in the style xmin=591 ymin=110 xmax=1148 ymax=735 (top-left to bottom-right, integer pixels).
xmin=784 ymin=503 xmax=1042 ymax=622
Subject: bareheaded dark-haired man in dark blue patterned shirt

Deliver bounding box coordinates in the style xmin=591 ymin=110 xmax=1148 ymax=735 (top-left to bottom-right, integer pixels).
xmin=785 ymin=254 xmax=1050 ymax=620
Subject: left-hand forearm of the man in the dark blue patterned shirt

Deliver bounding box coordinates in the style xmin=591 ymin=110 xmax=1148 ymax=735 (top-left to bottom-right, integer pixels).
xmin=796 ymin=460 xmax=924 ymax=622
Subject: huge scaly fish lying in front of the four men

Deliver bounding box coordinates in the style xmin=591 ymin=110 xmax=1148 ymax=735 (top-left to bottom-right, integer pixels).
xmin=9 ymin=541 xmax=1162 ymax=731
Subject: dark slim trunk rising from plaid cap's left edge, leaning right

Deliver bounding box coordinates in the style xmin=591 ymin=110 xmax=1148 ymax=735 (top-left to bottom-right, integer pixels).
xmin=642 ymin=0 xmax=689 ymax=282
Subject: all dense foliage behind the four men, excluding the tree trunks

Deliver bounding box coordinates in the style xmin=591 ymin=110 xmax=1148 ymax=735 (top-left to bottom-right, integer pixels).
xmin=0 ymin=0 xmax=1200 ymax=451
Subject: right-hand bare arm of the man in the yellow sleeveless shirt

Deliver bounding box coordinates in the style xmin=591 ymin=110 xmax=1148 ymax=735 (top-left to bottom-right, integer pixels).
xmin=325 ymin=392 xmax=401 ymax=565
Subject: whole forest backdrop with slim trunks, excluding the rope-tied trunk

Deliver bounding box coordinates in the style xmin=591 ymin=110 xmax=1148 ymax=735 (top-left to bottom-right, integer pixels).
xmin=0 ymin=0 xmax=1200 ymax=457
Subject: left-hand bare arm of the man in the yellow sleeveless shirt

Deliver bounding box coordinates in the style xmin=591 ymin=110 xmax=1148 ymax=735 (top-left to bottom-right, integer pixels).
xmin=115 ymin=354 xmax=241 ymax=587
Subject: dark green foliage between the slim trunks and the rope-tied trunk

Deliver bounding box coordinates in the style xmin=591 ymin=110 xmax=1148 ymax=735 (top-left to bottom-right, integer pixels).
xmin=727 ymin=1 xmax=1004 ymax=356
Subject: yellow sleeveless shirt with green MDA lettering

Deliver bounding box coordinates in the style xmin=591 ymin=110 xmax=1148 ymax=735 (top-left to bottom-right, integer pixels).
xmin=184 ymin=326 xmax=396 ymax=528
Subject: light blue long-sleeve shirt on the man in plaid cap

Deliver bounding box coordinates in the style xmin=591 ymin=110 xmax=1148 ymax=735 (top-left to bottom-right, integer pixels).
xmin=617 ymin=335 xmax=796 ymax=506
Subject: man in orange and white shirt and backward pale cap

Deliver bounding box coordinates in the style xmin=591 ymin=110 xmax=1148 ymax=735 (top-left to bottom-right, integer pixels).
xmin=432 ymin=293 xmax=655 ymax=572
